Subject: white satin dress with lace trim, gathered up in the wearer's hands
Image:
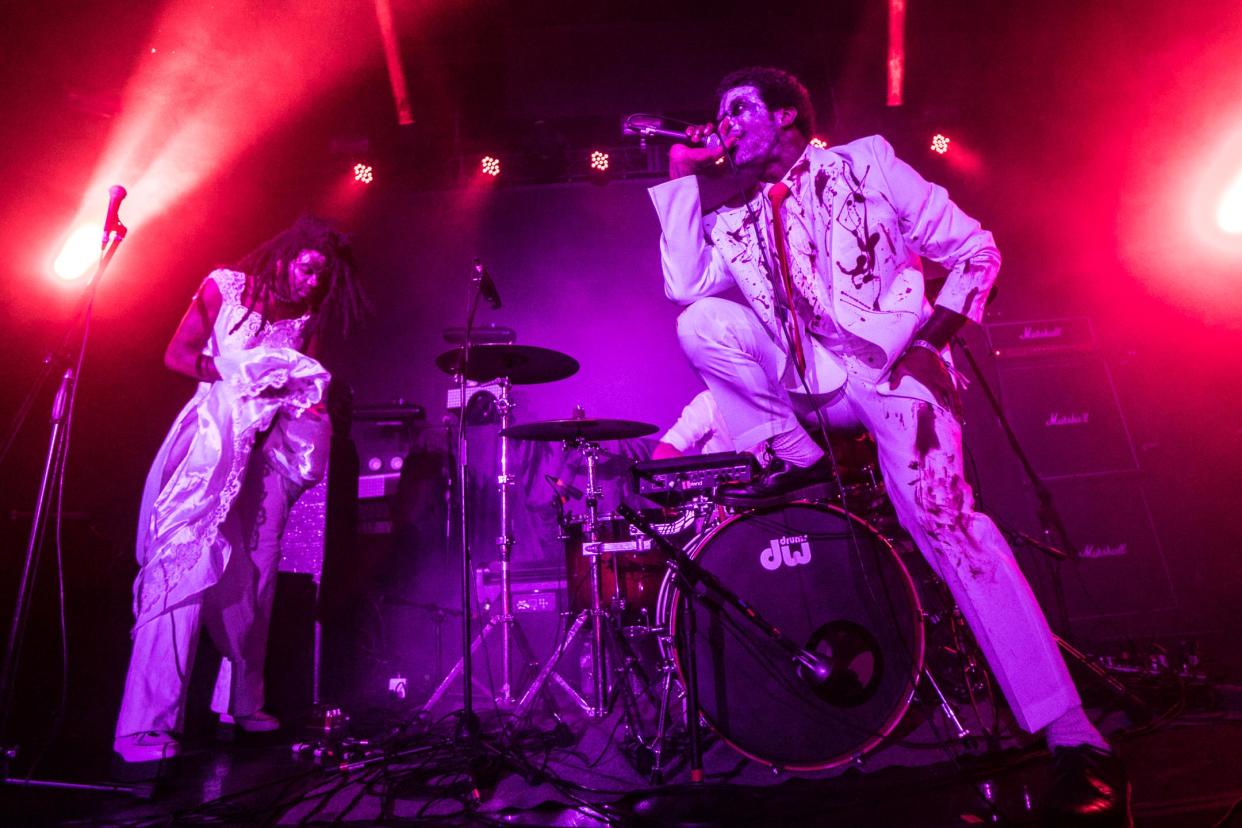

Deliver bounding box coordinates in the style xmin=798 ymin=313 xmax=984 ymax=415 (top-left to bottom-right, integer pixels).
xmin=134 ymin=269 xmax=330 ymax=629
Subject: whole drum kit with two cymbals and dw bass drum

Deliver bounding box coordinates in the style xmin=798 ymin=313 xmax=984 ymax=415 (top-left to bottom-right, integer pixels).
xmin=424 ymin=344 xmax=966 ymax=778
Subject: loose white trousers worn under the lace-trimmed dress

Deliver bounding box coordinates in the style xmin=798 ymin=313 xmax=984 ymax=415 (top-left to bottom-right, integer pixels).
xmin=117 ymin=444 xmax=302 ymax=739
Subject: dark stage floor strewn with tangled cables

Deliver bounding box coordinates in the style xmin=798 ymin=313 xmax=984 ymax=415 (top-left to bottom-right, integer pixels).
xmin=0 ymin=704 xmax=1242 ymax=828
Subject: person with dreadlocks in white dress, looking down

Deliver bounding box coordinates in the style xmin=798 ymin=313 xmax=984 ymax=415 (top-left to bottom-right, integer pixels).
xmin=113 ymin=218 xmax=361 ymax=762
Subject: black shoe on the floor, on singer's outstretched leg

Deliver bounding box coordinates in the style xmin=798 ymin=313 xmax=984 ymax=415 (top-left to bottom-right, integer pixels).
xmin=1043 ymin=745 xmax=1134 ymax=828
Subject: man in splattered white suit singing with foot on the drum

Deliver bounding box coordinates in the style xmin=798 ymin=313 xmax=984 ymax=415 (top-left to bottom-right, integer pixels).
xmin=651 ymin=67 xmax=1125 ymax=814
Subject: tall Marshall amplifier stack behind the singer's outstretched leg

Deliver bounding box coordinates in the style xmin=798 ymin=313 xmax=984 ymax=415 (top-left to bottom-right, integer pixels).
xmin=968 ymin=317 xmax=1176 ymax=633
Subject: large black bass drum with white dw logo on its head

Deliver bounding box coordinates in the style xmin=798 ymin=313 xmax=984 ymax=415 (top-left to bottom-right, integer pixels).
xmin=657 ymin=503 xmax=923 ymax=771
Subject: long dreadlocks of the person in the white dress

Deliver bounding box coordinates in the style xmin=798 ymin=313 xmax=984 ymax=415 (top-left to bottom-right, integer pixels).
xmin=230 ymin=216 xmax=366 ymax=341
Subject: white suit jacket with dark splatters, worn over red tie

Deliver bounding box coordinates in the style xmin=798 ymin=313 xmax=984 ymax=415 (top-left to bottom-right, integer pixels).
xmin=650 ymin=135 xmax=1000 ymax=392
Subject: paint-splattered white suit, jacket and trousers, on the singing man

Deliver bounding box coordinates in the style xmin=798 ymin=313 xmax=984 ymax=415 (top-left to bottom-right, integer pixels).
xmin=651 ymin=137 xmax=1079 ymax=731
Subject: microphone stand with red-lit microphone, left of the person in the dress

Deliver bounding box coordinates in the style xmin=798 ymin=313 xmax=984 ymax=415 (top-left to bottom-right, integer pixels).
xmin=0 ymin=228 xmax=154 ymax=798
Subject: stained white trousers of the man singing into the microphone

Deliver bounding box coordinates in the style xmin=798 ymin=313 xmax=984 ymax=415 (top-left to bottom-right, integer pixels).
xmin=677 ymin=298 xmax=1082 ymax=732
